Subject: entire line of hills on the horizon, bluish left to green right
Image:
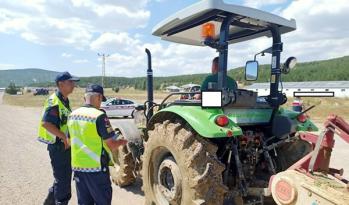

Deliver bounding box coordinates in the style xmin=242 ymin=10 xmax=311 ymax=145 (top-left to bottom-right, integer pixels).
xmin=0 ymin=56 xmax=349 ymax=89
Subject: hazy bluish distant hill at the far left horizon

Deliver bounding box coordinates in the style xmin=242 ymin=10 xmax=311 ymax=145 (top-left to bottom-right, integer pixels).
xmin=0 ymin=68 xmax=58 ymax=87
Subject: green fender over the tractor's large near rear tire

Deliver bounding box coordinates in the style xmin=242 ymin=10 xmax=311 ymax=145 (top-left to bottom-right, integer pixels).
xmin=147 ymin=105 xmax=242 ymax=138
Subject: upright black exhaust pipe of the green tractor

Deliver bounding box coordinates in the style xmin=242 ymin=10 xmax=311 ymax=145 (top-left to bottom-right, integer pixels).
xmin=145 ymin=48 xmax=154 ymax=123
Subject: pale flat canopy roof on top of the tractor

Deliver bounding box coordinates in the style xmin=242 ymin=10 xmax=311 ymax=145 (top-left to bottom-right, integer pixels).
xmin=153 ymin=0 xmax=296 ymax=46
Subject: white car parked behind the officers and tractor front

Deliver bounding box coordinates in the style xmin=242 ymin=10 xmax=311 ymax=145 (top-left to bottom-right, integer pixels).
xmin=101 ymin=98 xmax=137 ymax=118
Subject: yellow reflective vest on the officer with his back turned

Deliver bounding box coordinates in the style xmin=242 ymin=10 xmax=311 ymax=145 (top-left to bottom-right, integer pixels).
xmin=68 ymin=107 xmax=113 ymax=172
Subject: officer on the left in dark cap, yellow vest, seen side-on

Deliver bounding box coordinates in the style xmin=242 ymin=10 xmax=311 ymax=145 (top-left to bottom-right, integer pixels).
xmin=38 ymin=72 xmax=79 ymax=205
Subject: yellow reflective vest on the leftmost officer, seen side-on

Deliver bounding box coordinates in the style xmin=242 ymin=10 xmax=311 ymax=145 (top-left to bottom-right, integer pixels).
xmin=38 ymin=93 xmax=71 ymax=144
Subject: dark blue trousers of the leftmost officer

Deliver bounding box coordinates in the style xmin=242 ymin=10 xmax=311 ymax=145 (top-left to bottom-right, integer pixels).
xmin=44 ymin=142 xmax=72 ymax=205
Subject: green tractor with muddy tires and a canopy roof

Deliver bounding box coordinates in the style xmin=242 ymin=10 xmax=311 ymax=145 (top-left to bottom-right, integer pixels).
xmin=111 ymin=0 xmax=318 ymax=205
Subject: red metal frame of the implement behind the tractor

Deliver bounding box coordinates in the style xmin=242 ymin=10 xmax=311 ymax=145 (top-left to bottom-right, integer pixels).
xmin=288 ymin=115 xmax=349 ymax=184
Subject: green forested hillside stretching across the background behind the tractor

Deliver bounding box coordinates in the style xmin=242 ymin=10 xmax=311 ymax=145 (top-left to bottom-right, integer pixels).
xmin=80 ymin=56 xmax=349 ymax=89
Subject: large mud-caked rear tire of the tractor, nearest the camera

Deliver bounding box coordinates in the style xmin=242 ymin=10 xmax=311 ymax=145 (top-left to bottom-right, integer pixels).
xmin=141 ymin=120 xmax=228 ymax=205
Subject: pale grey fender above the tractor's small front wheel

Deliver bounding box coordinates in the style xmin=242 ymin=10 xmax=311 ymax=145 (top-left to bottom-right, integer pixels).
xmin=110 ymin=120 xmax=142 ymax=144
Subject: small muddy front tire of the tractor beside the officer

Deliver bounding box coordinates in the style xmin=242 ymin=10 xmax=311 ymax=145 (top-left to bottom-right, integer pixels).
xmin=110 ymin=135 xmax=136 ymax=187
